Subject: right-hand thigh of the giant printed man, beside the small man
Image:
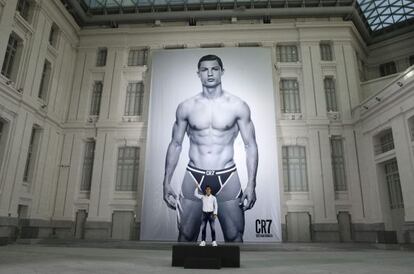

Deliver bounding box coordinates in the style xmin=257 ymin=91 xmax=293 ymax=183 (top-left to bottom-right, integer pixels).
xmin=218 ymin=199 xmax=244 ymax=242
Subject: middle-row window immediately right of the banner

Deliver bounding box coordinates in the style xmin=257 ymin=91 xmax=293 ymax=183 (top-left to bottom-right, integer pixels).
xmin=280 ymin=79 xmax=301 ymax=113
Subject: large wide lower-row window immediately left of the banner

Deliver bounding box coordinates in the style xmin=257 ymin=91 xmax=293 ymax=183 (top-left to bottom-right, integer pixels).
xmin=115 ymin=147 xmax=139 ymax=191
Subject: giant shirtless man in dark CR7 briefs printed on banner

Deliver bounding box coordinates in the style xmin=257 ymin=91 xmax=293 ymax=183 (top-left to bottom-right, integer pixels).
xmin=163 ymin=55 xmax=258 ymax=242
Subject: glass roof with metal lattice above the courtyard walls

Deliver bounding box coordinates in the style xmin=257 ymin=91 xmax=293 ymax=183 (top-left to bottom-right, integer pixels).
xmin=76 ymin=0 xmax=414 ymax=32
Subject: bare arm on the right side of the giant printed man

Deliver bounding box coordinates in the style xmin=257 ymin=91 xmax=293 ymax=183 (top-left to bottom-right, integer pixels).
xmin=237 ymin=102 xmax=259 ymax=210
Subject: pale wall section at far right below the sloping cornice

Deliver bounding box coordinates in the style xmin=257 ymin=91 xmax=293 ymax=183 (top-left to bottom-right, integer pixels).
xmin=355 ymin=67 xmax=414 ymax=227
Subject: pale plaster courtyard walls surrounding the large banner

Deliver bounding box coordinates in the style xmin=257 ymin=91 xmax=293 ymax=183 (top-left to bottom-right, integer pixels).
xmin=0 ymin=0 xmax=414 ymax=240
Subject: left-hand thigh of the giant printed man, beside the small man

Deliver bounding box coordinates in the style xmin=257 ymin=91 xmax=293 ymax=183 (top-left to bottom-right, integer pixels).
xmin=177 ymin=197 xmax=203 ymax=242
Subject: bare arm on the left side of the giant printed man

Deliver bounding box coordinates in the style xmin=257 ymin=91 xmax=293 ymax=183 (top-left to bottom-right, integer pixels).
xmin=163 ymin=103 xmax=188 ymax=209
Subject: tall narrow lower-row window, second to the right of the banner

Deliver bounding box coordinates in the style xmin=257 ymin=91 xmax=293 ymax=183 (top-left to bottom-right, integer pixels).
xmin=331 ymin=136 xmax=347 ymax=191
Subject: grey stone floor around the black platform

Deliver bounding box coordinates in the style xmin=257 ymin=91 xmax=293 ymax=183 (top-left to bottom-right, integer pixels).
xmin=0 ymin=243 xmax=414 ymax=274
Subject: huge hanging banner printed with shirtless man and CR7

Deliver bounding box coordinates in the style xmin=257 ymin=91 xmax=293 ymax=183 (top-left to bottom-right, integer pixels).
xmin=141 ymin=48 xmax=281 ymax=242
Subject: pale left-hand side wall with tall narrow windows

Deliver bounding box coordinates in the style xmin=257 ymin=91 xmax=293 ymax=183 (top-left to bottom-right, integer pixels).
xmin=0 ymin=0 xmax=78 ymax=220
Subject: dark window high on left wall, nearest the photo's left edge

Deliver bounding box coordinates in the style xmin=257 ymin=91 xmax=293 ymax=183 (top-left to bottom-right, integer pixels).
xmin=1 ymin=33 xmax=23 ymax=81
